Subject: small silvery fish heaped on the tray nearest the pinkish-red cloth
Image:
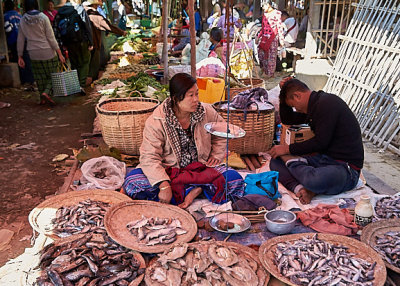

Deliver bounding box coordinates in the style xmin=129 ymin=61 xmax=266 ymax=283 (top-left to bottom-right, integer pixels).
xmin=275 ymin=235 xmax=376 ymax=286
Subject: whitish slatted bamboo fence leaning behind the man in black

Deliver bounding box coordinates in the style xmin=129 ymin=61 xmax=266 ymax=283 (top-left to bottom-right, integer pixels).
xmin=324 ymin=0 xmax=400 ymax=155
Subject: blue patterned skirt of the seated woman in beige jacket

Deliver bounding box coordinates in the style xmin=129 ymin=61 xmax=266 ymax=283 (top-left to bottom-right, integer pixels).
xmin=122 ymin=166 xmax=245 ymax=204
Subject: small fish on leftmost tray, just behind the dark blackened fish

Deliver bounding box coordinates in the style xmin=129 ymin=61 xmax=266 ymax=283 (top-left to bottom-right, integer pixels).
xmin=51 ymin=199 xmax=110 ymax=237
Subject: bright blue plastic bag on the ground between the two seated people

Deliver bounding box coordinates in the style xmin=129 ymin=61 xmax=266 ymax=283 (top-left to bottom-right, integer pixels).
xmin=244 ymin=171 xmax=282 ymax=200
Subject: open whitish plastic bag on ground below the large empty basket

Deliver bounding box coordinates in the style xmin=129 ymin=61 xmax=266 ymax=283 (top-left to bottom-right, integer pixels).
xmin=78 ymin=156 xmax=126 ymax=190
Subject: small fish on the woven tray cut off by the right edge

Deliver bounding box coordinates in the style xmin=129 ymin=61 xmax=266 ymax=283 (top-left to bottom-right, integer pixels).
xmin=374 ymin=231 xmax=400 ymax=267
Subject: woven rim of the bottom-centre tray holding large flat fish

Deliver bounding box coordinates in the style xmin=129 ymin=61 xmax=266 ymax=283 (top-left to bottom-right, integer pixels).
xmin=144 ymin=241 xmax=270 ymax=286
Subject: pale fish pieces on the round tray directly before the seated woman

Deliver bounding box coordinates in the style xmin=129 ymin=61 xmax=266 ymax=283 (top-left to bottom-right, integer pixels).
xmin=126 ymin=215 xmax=187 ymax=246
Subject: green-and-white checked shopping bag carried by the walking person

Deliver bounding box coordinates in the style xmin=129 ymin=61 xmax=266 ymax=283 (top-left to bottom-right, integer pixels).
xmin=51 ymin=64 xmax=81 ymax=96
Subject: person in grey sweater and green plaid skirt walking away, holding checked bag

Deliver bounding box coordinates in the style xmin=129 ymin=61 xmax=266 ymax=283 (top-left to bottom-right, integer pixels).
xmin=17 ymin=0 xmax=65 ymax=105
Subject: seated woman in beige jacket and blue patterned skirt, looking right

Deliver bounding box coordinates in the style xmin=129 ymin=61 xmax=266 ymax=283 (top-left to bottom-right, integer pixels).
xmin=123 ymin=73 xmax=244 ymax=208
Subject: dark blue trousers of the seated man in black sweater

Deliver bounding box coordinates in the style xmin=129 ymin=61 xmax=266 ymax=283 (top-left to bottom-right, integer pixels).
xmin=270 ymin=154 xmax=360 ymax=195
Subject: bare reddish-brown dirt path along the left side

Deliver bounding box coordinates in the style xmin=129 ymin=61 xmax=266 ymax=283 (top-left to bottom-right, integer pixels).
xmin=0 ymin=88 xmax=95 ymax=266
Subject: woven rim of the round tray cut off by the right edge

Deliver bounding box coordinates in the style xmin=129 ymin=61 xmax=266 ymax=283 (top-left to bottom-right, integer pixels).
xmin=361 ymin=218 xmax=400 ymax=273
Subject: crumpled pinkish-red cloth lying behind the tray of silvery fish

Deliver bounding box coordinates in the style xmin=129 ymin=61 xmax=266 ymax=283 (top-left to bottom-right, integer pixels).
xmin=297 ymin=204 xmax=358 ymax=235
